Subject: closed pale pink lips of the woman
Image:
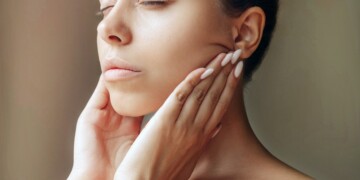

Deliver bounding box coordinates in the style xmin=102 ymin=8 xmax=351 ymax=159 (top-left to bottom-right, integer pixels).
xmin=102 ymin=58 xmax=142 ymax=81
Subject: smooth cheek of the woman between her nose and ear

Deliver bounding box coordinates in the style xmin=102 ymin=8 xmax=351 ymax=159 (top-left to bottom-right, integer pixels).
xmin=134 ymin=10 xmax=225 ymax=87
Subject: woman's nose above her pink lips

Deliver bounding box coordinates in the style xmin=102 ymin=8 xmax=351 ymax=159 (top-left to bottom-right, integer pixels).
xmin=97 ymin=2 xmax=132 ymax=46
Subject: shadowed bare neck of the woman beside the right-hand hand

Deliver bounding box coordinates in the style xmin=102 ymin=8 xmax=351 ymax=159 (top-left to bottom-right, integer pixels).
xmin=191 ymin=86 xmax=269 ymax=179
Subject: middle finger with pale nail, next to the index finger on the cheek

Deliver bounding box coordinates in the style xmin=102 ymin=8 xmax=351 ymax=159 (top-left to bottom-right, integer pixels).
xmin=177 ymin=53 xmax=225 ymax=126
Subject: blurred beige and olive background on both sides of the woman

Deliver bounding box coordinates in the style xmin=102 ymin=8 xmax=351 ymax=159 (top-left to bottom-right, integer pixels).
xmin=0 ymin=0 xmax=360 ymax=180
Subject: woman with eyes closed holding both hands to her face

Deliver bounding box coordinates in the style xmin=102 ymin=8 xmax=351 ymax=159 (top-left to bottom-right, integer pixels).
xmin=68 ymin=0 xmax=310 ymax=180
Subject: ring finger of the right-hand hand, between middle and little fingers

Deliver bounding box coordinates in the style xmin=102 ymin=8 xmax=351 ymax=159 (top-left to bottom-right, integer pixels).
xmin=194 ymin=53 xmax=233 ymax=133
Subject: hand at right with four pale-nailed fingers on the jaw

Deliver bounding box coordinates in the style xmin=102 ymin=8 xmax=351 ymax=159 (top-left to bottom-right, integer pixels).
xmin=115 ymin=52 xmax=242 ymax=180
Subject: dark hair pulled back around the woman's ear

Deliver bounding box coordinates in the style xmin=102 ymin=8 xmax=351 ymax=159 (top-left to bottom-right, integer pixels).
xmin=220 ymin=0 xmax=279 ymax=83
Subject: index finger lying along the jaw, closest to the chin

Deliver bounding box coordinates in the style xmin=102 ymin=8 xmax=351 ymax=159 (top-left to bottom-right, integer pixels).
xmin=154 ymin=68 xmax=205 ymax=123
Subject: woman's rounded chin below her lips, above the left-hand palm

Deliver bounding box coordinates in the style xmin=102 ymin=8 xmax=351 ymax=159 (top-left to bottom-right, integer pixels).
xmin=110 ymin=93 xmax=163 ymax=117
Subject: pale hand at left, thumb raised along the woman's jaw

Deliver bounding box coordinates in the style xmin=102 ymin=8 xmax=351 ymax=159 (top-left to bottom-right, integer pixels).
xmin=68 ymin=77 xmax=143 ymax=180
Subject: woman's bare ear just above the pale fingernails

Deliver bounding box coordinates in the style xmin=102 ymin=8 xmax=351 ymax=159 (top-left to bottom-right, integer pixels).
xmin=232 ymin=7 xmax=265 ymax=59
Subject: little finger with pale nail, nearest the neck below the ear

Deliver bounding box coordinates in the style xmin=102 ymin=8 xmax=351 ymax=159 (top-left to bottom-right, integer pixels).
xmin=205 ymin=61 xmax=244 ymax=136
